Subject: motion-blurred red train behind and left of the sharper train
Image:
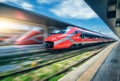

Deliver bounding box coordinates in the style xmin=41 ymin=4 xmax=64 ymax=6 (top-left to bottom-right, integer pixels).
xmin=15 ymin=29 xmax=44 ymax=45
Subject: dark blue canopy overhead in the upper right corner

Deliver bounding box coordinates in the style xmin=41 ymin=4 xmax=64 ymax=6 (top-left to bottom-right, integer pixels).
xmin=85 ymin=0 xmax=120 ymax=38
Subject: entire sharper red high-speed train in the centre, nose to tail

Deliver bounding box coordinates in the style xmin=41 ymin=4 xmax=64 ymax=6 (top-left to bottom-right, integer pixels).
xmin=45 ymin=26 xmax=113 ymax=49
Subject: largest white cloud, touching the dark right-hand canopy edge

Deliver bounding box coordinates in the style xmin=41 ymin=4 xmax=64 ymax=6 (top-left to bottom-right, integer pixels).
xmin=50 ymin=0 xmax=98 ymax=19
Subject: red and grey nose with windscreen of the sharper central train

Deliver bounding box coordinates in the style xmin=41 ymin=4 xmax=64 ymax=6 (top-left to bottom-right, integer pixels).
xmin=45 ymin=28 xmax=72 ymax=49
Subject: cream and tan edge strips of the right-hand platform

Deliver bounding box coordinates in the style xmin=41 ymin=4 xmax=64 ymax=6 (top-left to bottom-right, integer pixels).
xmin=58 ymin=43 xmax=117 ymax=81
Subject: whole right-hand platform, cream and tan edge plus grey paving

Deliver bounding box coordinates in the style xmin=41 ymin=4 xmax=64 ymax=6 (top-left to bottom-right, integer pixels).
xmin=59 ymin=42 xmax=120 ymax=81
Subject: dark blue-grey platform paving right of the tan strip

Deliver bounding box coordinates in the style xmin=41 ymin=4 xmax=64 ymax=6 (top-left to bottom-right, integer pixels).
xmin=91 ymin=43 xmax=120 ymax=81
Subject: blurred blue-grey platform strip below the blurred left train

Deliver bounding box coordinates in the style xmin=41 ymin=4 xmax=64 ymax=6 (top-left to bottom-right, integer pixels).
xmin=0 ymin=45 xmax=44 ymax=58
